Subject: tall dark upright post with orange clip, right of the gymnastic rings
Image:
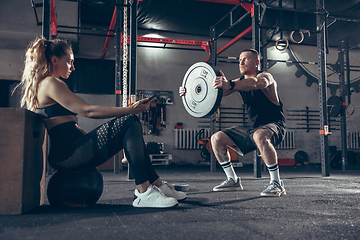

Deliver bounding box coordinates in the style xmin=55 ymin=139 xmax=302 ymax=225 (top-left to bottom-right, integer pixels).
xmin=316 ymin=0 xmax=330 ymax=177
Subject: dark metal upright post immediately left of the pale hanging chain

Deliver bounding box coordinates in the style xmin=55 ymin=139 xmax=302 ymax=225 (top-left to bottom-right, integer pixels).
xmin=114 ymin=0 xmax=122 ymax=174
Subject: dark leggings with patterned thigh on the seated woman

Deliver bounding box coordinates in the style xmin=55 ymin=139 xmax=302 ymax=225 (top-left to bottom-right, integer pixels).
xmin=49 ymin=115 xmax=159 ymax=185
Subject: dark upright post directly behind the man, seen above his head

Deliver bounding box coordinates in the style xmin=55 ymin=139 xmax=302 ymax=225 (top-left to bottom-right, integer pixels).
xmin=252 ymin=3 xmax=261 ymax=178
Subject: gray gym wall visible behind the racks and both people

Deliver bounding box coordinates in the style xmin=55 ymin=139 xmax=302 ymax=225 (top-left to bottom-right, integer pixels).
xmin=0 ymin=0 xmax=360 ymax=164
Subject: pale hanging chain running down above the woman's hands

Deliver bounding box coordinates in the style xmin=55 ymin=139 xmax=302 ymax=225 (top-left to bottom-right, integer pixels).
xmin=123 ymin=0 xmax=128 ymax=107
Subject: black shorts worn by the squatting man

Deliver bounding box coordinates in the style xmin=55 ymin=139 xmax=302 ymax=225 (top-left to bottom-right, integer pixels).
xmin=221 ymin=121 xmax=286 ymax=155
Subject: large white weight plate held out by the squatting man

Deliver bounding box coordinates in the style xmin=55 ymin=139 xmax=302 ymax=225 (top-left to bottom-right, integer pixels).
xmin=182 ymin=62 xmax=223 ymax=118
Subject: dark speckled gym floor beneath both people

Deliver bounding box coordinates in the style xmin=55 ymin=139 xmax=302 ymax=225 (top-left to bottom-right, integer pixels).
xmin=0 ymin=165 xmax=360 ymax=240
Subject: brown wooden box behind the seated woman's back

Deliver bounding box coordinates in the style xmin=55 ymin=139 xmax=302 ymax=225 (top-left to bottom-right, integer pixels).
xmin=0 ymin=108 xmax=45 ymax=215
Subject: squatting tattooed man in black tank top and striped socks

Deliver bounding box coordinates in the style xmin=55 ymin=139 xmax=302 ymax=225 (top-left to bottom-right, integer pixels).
xmin=179 ymin=49 xmax=286 ymax=196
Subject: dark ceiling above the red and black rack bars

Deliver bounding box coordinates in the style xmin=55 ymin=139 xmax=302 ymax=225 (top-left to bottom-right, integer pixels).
xmin=77 ymin=0 xmax=360 ymax=47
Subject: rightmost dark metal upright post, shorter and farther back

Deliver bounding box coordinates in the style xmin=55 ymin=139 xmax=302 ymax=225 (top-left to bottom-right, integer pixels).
xmin=338 ymin=40 xmax=348 ymax=170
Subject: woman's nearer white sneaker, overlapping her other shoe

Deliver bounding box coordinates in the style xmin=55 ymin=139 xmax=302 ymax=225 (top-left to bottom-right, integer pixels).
xmin=133 ymin=186 xmax=178 ymax=208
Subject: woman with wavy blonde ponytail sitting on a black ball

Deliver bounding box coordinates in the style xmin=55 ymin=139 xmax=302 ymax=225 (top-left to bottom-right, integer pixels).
xmin=14 ymin=38 xmax=186 ymax=208
